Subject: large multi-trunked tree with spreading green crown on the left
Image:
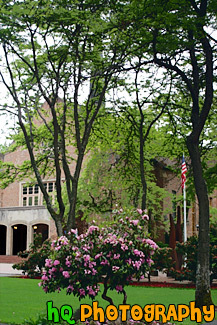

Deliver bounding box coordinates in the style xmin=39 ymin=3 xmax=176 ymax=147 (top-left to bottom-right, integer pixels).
xmin=0 ymin=0 xmax=127 ymax=236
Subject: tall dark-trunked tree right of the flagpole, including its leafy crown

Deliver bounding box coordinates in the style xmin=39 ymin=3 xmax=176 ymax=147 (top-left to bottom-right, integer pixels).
xmin=127 ymin=0 xmax=217 ymax=307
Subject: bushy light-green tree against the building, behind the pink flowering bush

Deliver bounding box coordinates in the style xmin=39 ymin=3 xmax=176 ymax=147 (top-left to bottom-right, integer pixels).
xmin=78 ymin=109 xmax=168 ymax=225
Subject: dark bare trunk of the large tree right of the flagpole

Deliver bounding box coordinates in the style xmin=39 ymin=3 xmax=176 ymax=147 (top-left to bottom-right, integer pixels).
xmin=187 ymin=135 xmax=212 ymax=308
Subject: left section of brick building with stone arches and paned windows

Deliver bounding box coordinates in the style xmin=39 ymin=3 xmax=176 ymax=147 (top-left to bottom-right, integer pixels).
xmin=0 ymin=149 xmax=56 ymax=255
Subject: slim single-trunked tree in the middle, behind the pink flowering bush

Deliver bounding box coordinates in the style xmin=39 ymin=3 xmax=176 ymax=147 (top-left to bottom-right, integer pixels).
xmin=110 ymin=62 xmax=172 ymax=210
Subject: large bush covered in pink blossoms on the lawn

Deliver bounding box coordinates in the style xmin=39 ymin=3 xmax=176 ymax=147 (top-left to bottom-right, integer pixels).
xmin=39 ymin=209 xmax=158 ymax=304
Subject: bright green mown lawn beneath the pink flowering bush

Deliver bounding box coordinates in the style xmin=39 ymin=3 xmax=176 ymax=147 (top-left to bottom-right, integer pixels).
xmin=0 ymin=277 xmax=217 ymax=325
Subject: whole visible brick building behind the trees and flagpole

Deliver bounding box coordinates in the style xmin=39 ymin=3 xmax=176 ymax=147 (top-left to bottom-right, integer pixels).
xmin=0 ymin=135 xmax=217 ymax=255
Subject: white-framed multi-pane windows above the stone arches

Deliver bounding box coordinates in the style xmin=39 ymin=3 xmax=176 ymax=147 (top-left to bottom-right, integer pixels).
xmin=21 ymin=181 xmax=55 ymax=207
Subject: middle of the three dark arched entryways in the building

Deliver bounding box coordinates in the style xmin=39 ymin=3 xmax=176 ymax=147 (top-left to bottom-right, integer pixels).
xmin=12 ymin=224 xmax=27 ymax=255
